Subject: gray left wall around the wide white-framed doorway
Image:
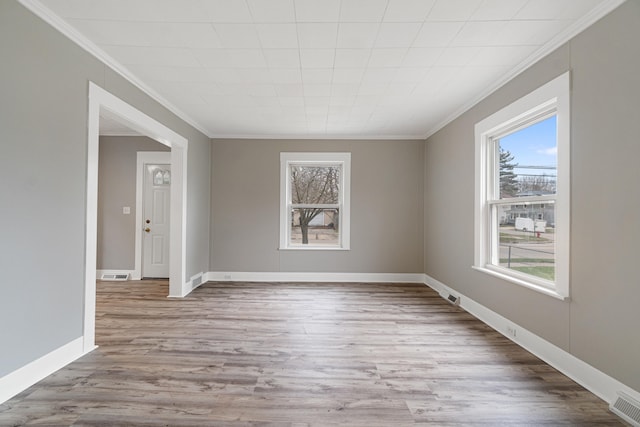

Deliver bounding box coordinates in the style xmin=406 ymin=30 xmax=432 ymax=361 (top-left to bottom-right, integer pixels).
xmin=0 ymin=0 xmax=210 ymax=376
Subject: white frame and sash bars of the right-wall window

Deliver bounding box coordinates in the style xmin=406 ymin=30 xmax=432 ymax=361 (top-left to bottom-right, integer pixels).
xmin=473 ymin=72 xmax=571 ymax=300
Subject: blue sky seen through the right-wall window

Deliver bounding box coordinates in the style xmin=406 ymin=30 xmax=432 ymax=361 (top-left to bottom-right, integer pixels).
xmin=500 ymin=116 xmax=558 ymax=175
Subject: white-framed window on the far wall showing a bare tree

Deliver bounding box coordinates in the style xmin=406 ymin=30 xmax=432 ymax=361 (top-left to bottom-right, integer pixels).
xmin=280 ymin=153 xmax=351 ymax=249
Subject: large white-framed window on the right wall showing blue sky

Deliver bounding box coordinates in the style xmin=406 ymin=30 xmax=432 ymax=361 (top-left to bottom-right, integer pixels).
xmin=474 ymin=73 xmax=570 ymax=299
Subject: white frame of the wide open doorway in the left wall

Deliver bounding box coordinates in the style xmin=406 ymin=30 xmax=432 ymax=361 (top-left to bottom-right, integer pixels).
xmin=83 ymin=82 xmax=188 ymax=352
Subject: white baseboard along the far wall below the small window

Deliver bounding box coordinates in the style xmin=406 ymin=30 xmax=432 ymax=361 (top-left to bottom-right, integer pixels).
xmin=204 ymin=271 xmax=424 ymax=283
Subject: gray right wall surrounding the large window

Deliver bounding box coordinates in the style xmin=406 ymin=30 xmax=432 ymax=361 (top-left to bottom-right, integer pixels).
xmin=424 ymin=1 xmax=640 ymax=390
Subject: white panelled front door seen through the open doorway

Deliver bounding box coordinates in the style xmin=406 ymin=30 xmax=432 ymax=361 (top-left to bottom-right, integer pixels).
xmin=142 ymin=164 xmax=171 ymax=278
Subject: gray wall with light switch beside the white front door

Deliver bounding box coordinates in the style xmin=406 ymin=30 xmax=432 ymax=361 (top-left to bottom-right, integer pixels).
xmin=97 ymin=136 xmax=170 ymax=270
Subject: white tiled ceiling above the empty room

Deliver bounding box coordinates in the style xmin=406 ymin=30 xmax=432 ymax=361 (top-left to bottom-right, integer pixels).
xmin=32 ymin=0 xmax=621 ymax=138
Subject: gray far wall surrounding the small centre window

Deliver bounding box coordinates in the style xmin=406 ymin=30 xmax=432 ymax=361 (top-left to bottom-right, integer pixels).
xmin=211 ymin=140 xmax=424 ymax=273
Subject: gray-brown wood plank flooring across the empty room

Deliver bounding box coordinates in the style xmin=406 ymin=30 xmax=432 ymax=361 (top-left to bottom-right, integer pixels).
xmin=0 ymin=281 xmax=624 ymax=427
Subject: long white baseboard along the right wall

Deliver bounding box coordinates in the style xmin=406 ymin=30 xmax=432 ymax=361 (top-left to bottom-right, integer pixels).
xmin=424 ymin=274 xmax=640 ymax=404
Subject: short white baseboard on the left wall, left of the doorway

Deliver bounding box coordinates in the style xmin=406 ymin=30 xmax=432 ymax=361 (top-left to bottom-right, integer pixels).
xmin=0 ymin=337 xmax=85 ymax=404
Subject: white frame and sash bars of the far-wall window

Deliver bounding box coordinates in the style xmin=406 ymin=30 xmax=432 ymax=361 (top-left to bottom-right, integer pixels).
xmin=279 ymin=152 xmax=351 ymax=251
